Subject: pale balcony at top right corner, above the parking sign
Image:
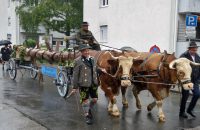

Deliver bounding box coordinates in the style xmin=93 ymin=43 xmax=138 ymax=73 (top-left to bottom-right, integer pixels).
xmin=179 ymin=0 xmax=200 ymax=13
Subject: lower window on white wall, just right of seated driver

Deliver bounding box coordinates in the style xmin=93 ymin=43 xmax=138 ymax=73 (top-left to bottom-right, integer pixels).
xmin=100 ymin=25 xmax=108 ymax=42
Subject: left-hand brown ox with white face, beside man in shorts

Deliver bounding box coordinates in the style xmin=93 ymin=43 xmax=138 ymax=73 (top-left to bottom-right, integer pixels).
xmin=95 ymin=51 xmax=141 ymax=116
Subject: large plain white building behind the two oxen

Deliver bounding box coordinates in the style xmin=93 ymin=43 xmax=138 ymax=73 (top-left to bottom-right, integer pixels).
xmin=84 ymin=0 xmax=200 ymax=56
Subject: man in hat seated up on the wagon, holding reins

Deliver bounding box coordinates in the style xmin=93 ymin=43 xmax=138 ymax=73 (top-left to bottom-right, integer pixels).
xmin=76 ymin=22 xmax=101 ymax=51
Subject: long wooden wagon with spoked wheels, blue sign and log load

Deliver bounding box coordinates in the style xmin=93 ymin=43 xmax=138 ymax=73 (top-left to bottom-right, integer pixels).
xmin=8 ymin=42 xmax=76 ymax=97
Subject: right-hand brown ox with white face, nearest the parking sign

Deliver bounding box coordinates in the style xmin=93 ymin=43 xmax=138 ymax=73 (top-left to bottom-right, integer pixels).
xmin=122 ymin=51 xmax=200 ymax=121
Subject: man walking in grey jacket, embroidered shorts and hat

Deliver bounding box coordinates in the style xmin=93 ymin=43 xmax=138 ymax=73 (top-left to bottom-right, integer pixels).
xmin=72 ymin=44 xmax=105 ymax=124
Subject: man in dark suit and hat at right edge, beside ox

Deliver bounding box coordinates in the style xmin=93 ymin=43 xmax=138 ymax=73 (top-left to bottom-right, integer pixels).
xmin=179 ymin=41 xmax=200 ymax=118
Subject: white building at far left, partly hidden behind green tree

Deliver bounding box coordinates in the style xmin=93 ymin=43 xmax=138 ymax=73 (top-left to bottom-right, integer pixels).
xmin=0 ymin=0 xmax=65 ymax=47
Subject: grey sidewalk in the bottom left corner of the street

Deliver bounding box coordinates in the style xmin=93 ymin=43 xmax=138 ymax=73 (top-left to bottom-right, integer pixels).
xmin=0 ymin=103 xmax=46 ymax=130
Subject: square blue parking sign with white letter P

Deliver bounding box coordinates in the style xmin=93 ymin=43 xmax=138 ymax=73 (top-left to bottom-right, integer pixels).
xmin=186 ymin=15 xmax=198 ymax=27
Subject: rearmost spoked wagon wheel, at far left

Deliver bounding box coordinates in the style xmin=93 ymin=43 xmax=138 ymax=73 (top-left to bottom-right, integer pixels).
xmin=8 ymin=59 xmax=17 ymax=80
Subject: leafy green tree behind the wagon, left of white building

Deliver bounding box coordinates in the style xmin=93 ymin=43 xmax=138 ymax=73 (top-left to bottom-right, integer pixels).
xmin=16 ymin=0 xmax=83 ymax=35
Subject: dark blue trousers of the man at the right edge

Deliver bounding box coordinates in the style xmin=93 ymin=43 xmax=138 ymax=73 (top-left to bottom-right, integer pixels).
xmin=180 ymin=84 xmax=200 ymax=114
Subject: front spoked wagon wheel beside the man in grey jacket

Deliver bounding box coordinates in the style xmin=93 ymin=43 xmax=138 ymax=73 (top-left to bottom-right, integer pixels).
xmin=56 ymin=71 xmax=69 ymax=98
